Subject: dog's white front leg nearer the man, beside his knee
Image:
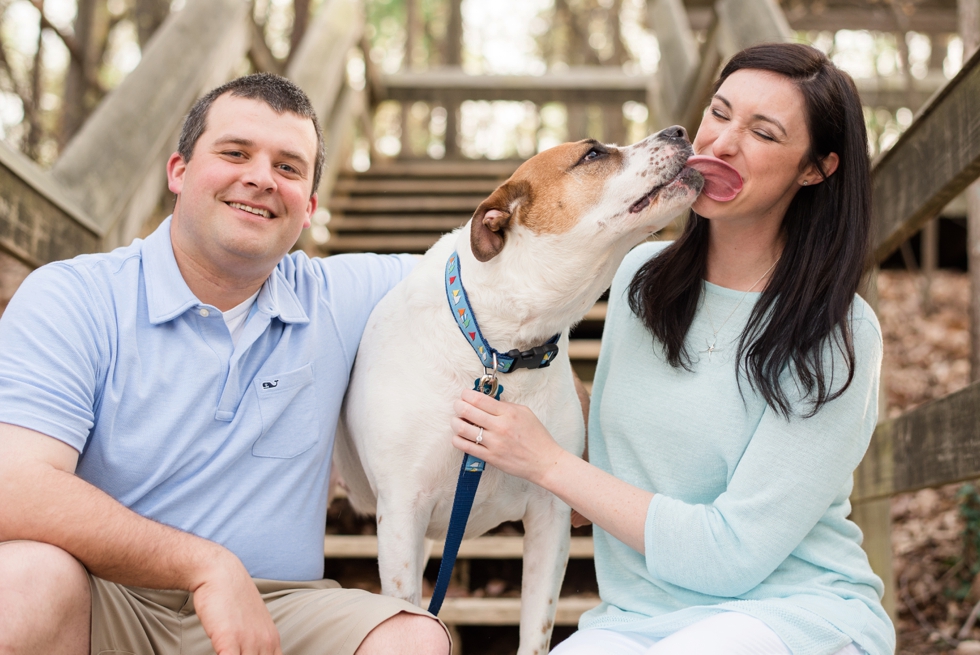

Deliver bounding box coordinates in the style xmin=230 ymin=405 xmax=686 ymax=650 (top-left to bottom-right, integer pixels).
xmin=377 ymin=490 xmax=432 ymax=605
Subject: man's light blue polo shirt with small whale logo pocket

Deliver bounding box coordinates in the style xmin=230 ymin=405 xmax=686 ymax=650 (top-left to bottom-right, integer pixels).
xmin=0 ymin=219 xmax=415 ymax=580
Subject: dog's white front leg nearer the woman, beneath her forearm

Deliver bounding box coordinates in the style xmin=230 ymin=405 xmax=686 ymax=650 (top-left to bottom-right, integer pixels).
xmin=517 ymin=490 xmax=571 ymax=655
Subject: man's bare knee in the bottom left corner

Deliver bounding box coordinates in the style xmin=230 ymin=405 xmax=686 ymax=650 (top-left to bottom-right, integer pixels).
xmin=0 ymin=541 xmax=92 ymax=653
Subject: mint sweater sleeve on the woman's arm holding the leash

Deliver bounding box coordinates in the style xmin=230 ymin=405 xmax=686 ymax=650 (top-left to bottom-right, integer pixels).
xmin=644 ymin=310 xmax=882 ymax=597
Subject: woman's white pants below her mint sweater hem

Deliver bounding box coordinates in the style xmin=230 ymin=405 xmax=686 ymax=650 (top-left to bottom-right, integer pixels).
xmin=551 ymin=612 xmax=863 ymax=655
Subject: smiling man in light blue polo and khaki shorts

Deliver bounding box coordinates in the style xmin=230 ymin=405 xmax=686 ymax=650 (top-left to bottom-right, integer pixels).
xmin=0 ymin=75 xmax=449 ymax=655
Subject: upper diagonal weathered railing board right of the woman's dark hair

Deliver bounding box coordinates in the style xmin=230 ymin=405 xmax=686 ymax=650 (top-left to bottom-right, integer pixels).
xmin=873 ymin=46 xmax=980 ymax=262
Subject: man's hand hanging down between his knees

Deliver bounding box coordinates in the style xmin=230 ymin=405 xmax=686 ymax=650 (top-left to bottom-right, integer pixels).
xmin=193 ymin=549 xmax=282 ymax=655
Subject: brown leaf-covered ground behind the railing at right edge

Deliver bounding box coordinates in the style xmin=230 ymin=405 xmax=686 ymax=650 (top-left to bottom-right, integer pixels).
xmin=878 ymin=271 xmax=980 ymax=655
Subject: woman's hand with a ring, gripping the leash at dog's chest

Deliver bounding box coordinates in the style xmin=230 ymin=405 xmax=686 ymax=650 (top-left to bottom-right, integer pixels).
xmin=452 ymin=389 xmax=568 ymax=486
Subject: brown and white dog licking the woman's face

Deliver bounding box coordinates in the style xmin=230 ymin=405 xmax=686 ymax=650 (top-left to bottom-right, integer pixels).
xmin=335 ymin=128 xmax=704 ymax=655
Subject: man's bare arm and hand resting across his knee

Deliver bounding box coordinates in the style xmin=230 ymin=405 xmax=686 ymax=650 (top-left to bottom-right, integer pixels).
xmin=0 ymin=423 xmax=281 ymax=655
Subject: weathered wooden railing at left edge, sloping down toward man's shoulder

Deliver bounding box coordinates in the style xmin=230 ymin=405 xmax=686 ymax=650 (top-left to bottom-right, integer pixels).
xmin=0 ymin=143 xmax=101 ymax=268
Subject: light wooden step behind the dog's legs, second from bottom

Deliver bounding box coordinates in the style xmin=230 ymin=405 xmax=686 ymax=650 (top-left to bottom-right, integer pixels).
xmin=323 ymin=534 xmax=594 ymax=559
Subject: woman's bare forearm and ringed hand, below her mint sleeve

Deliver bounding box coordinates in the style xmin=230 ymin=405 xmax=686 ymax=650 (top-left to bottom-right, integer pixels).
xmin=452 ymin=389 xmax=653 ymax=554
